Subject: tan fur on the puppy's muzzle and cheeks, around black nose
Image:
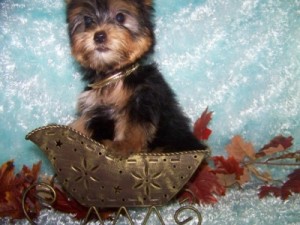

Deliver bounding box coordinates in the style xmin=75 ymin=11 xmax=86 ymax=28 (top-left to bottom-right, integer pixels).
xmin=72 ymin=24 xmax=152 ymax=72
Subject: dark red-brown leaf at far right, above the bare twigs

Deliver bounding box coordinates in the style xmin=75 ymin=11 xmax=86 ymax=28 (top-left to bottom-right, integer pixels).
xmin=255 ymin=135 xmax=293 ymax=158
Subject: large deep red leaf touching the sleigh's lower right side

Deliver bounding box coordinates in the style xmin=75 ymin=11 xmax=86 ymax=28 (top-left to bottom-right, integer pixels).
xmin=179 ymin=165 xmax=226 ymax=204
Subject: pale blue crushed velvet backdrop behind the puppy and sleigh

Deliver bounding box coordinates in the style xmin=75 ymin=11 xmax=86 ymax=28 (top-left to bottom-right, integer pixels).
xmin=0 ymin=0 xmax=300 ymax=224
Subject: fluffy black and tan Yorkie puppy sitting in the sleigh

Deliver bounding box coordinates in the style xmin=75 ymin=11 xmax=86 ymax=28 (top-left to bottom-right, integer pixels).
xmin=67 ymin=0 xmax=206 ymax=157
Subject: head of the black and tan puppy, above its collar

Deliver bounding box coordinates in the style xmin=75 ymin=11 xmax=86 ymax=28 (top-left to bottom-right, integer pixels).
xmin=67 ymin=0 xmax=154 ymax=72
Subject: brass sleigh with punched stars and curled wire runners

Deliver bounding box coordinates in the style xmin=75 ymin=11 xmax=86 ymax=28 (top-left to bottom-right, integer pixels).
xmin=23 ymin=125 xmax=210 ymax=224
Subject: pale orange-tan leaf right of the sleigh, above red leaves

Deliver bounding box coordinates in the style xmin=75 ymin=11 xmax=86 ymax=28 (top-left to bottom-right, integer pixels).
xmin=226 ymin=135 xmax=255 ymax=162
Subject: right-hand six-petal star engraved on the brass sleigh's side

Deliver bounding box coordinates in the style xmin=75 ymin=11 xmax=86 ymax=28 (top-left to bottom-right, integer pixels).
xmin=131 ymin=164 xmax=161 ymax=196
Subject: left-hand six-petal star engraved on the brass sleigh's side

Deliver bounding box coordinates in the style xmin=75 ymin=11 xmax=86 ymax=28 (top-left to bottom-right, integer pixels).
xmin=71 ymin=158 xmax=99 ymax=190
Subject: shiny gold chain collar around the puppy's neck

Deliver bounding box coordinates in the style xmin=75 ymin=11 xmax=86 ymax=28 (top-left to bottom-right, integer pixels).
xmin=88 ymin=64 xmax=140 ymax=89
